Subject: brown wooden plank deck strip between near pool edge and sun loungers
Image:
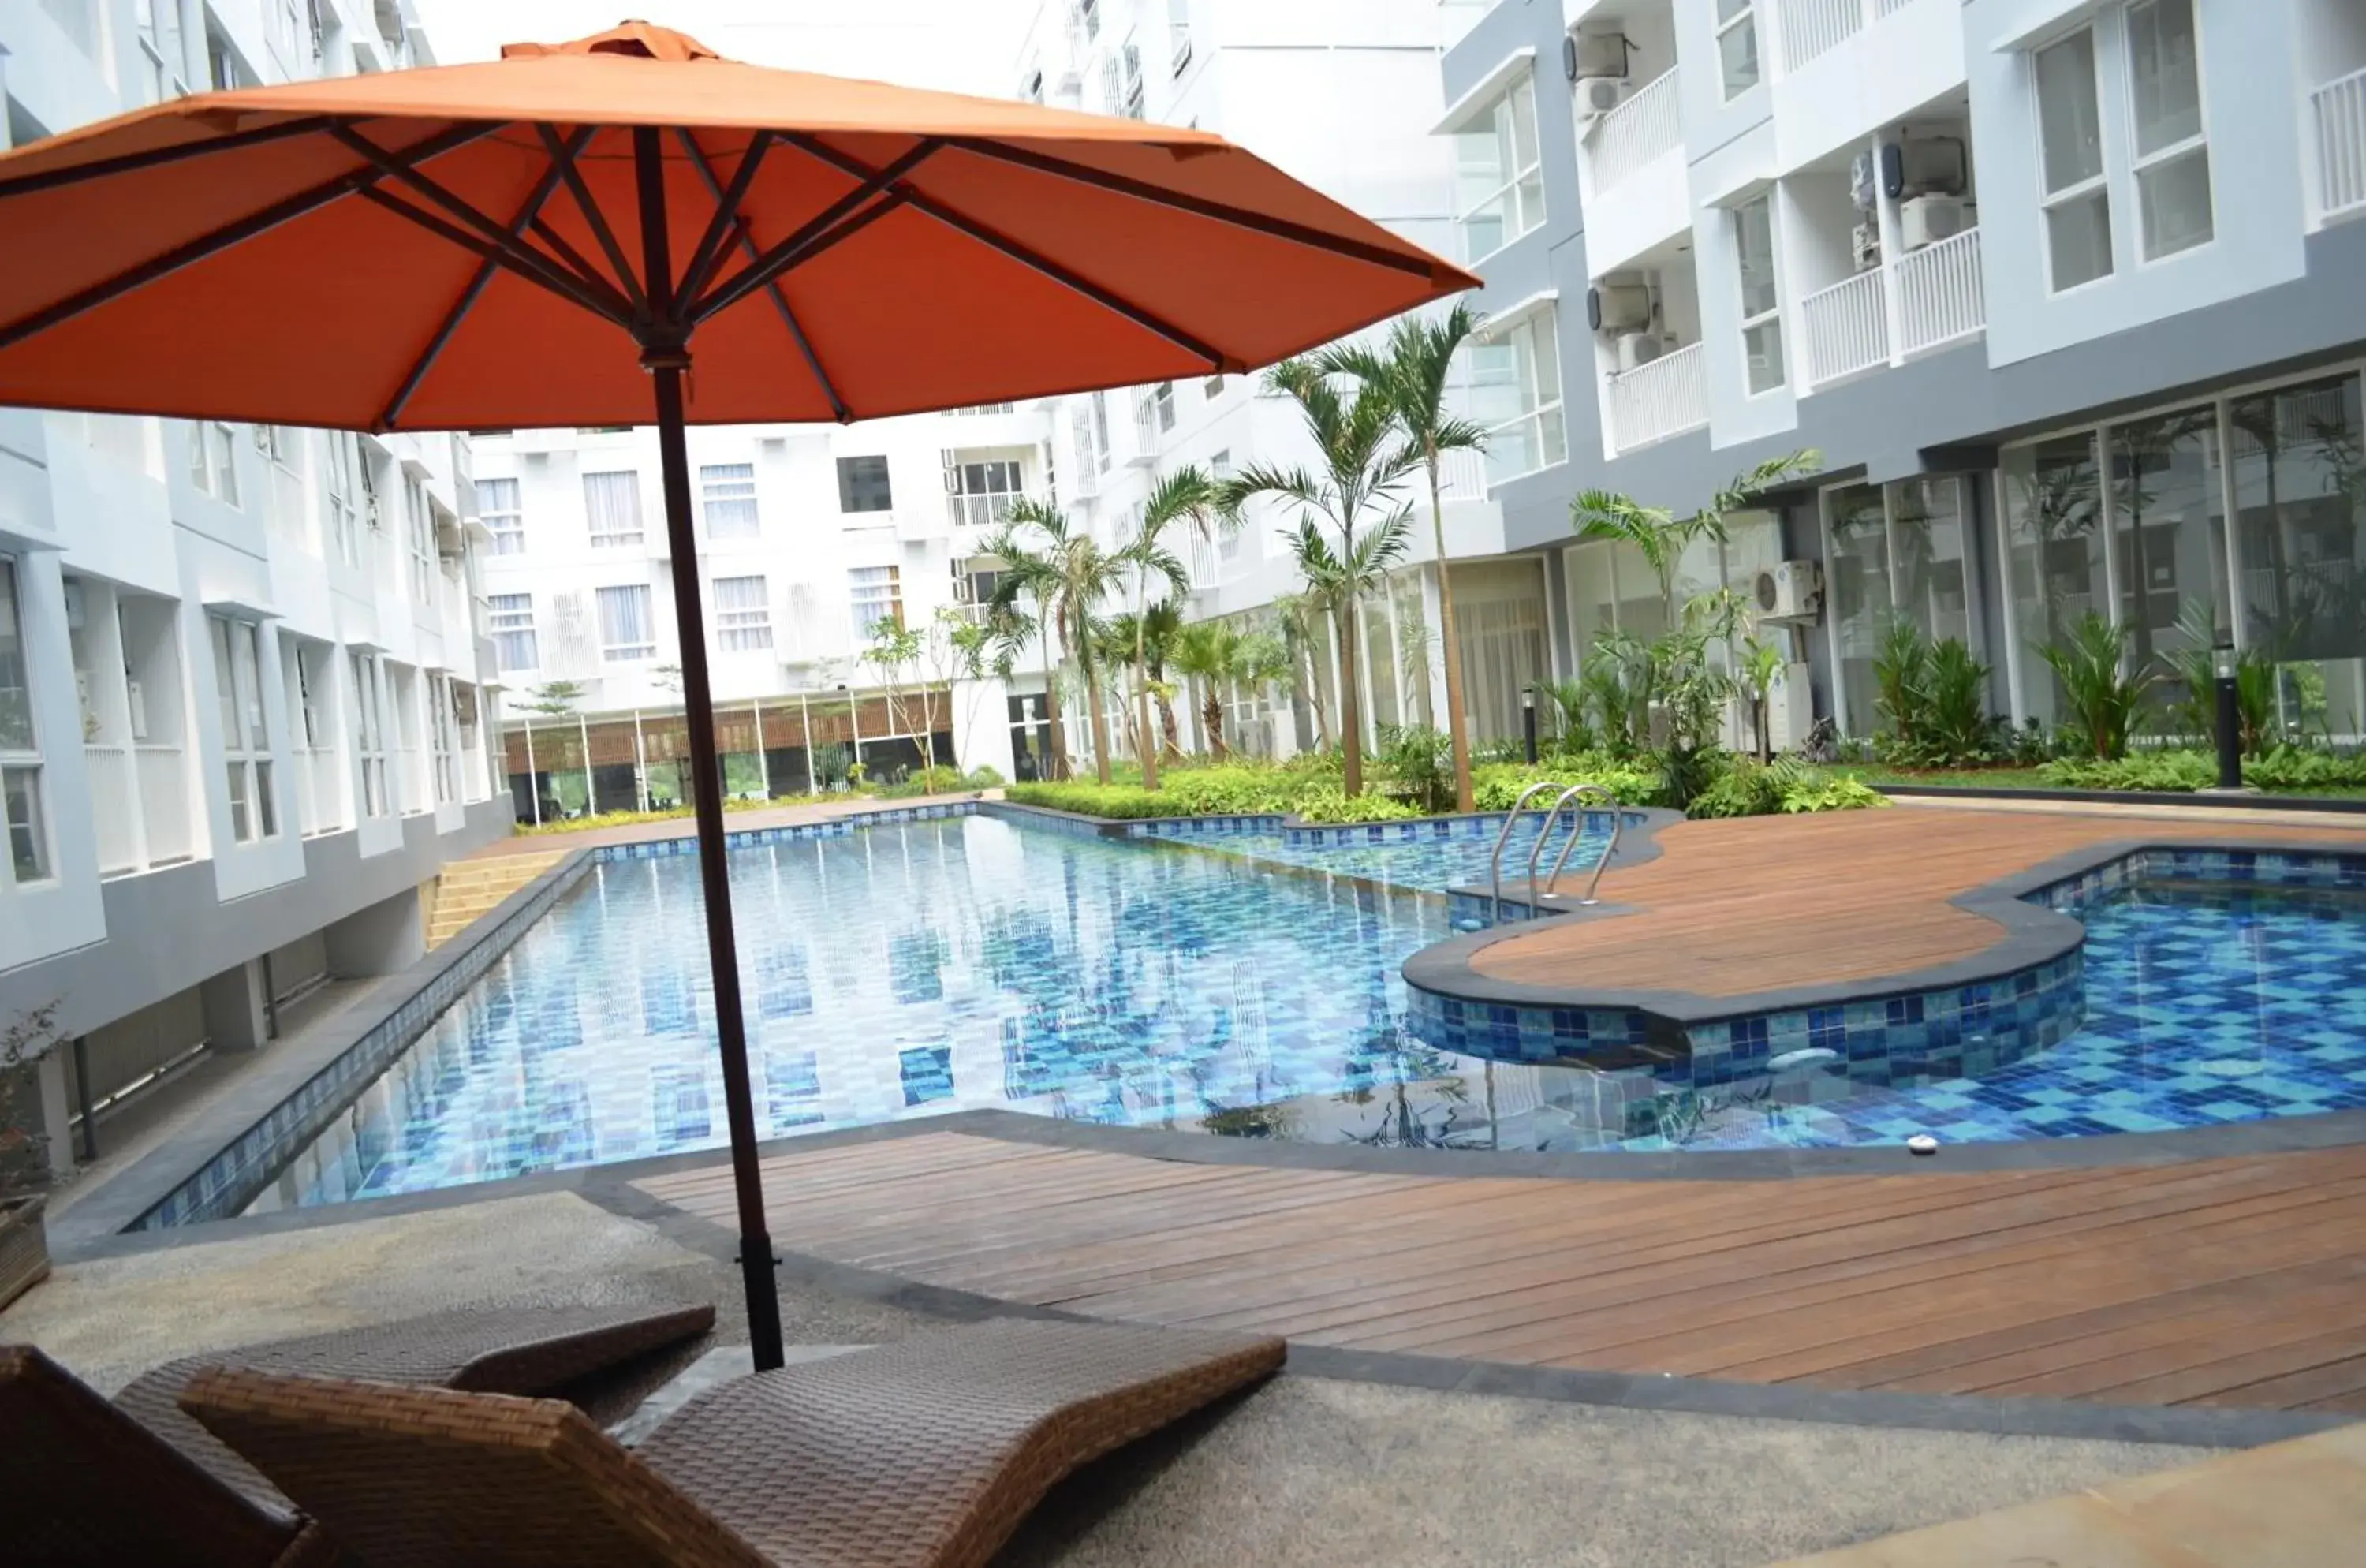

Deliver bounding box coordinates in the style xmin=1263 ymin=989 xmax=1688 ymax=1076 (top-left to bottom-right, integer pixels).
xmin=639 ymin=1133 xmax=2366 ymax=1414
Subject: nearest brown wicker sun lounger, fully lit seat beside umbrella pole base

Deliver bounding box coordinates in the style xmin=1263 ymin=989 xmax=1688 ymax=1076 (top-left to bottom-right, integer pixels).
xmin=182 ymin=1320 xmax=1282 ymax=1568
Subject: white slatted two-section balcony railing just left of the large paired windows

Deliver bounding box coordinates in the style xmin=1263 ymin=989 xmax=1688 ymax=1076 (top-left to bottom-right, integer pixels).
xmin=1798 ymin=227 xmax=1987 ymax=390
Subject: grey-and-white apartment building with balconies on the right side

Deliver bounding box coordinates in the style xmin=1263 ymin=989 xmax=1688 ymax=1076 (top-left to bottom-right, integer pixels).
xmin=1439 ymin=0 xmax=2366 ymax=741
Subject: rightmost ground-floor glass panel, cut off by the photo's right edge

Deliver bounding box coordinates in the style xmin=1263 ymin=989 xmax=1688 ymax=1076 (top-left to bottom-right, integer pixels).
xmin=2226 ymin=374 xmax=2366 ymax=743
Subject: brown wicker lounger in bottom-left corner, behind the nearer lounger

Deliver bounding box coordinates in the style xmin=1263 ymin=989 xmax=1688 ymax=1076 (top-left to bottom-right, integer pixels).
xmin=0 ymin=1308 xmax=715 ymax=1568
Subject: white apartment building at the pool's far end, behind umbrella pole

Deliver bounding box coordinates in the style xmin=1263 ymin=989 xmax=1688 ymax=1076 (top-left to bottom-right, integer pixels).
xmin=476 ymin=405 xmax=1058 ymax=818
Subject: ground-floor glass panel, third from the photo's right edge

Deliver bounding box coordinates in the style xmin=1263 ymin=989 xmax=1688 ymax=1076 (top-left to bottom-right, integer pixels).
xmin=1999 ymin=433 xmax=2113 ymax=729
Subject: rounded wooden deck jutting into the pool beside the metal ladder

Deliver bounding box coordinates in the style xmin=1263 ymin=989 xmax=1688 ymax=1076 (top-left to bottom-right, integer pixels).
xmin=1472 ymin=804 xmax=2366 ymax=995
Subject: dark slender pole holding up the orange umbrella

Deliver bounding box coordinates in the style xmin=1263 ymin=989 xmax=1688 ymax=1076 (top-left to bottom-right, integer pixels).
xmin=634 ymin=128 xmax=786 ymax=1372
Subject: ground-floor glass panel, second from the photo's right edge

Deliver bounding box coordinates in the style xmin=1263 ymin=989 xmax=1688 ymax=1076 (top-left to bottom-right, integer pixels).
xmin=2103 ymin=402 xmax=2234 ymax=703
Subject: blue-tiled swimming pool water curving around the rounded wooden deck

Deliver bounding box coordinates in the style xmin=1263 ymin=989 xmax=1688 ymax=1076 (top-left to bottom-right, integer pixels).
xmin=253 ymin=816 xmax=2366 ymax=1208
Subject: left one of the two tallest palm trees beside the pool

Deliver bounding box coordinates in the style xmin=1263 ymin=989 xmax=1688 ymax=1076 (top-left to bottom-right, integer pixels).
xmin=1218 ymin=360 xmax=1422 ymax=794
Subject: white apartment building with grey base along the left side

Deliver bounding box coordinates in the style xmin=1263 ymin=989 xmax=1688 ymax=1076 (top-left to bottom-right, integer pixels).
xmin=0 ymin=0 xmax=511 ymax=1163
